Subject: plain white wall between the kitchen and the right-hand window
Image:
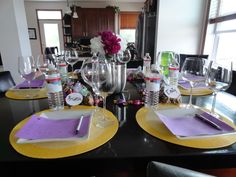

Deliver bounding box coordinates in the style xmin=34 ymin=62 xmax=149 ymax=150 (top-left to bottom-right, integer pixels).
xmin=157 ymin=0 xmax=206 ymax=54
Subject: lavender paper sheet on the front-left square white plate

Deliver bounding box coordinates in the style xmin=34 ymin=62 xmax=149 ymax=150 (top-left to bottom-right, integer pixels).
xmin=15 ymin=115 xmax=91 ymax=140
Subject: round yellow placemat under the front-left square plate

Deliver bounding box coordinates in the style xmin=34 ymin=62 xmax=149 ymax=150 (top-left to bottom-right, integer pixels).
xmin=9 ymin=106 xmax=119 ymax=159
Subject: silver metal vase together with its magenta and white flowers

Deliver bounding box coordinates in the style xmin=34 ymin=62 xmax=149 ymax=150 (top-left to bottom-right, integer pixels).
xmin=90 ymin=31 xmax=131 ymax=93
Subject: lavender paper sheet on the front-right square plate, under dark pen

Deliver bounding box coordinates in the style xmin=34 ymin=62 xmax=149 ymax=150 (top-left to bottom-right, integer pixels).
xmin=157 ymin=112 xmax=235 ymax=137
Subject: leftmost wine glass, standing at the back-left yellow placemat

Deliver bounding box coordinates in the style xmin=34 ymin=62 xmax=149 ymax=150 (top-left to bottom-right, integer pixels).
xmin=18 ymin=56 xmax=37 ymax=97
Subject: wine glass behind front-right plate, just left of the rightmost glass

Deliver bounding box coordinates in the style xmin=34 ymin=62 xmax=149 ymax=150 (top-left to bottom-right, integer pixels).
xmin=181 ymin=57 xmax=207 ymax=108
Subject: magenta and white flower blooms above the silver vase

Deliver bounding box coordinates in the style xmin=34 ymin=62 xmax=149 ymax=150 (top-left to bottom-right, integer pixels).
xmin=90 ymin=31 xmax=127 ymax=56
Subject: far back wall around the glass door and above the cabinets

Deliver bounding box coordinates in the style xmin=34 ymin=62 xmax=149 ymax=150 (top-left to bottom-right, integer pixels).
xmin=25 ymin=1 xmax=144 ymax=55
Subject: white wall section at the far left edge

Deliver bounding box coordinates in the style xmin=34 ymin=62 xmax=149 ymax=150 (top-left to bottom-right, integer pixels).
xmin=0 ymin=0 xmax=31 ymax=83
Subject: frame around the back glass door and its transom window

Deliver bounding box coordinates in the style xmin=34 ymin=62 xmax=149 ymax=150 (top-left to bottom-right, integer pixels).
xmin=36 ymin=9 xmax=65 ymax=54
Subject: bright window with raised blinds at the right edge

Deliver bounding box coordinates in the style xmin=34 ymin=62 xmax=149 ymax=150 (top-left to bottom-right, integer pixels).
xmin=204 ymin=0 xmax=236 ymax=68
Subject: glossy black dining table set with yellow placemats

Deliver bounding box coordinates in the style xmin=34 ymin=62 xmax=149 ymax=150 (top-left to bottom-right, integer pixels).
xmin=0 ymin=82 xmax=236 ymax=176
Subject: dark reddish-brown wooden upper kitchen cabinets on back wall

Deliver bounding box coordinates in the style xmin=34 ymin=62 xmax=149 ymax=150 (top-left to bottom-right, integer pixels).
xmin=72 ymin=7 xmax=115 ymax=40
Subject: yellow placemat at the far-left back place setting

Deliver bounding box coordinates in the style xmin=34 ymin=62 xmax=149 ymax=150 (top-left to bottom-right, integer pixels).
xmin=5 ymin=88 xmax=47 ymax=100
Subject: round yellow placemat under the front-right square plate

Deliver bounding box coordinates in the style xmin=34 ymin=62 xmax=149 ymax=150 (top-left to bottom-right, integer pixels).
xmin=136 ymin=105 xmax=236 ymax=149
